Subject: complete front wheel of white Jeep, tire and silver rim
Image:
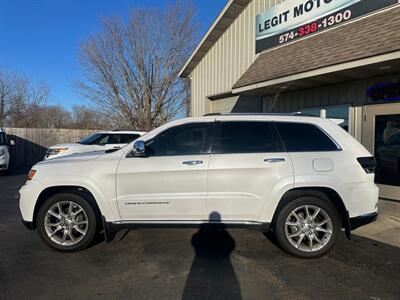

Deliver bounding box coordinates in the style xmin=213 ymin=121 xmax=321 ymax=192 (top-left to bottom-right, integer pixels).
xmin=36 ymin=193 xmax=97 ymax=252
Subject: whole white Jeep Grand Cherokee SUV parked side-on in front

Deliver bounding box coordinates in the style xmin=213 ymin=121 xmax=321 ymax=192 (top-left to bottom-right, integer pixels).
xmin=20 ymin=115 xmax=378 ymax=257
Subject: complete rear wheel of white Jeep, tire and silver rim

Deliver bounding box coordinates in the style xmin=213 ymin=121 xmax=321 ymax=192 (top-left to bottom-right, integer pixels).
xmin=274 ymin=196 xmax=340 ymax=258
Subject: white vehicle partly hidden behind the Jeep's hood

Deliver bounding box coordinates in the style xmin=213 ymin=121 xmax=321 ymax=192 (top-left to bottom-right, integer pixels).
xmin=44 ymin=131 xmax=144 ymax=160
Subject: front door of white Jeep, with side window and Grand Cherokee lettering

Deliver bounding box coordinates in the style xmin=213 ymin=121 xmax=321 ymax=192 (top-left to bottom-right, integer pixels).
xmin=116 ymin=122 xmax=211 ymax=222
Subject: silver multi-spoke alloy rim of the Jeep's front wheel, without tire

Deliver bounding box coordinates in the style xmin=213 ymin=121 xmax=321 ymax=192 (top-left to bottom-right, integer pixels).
xmin=44 ymin=201 xmax=89 ymax=246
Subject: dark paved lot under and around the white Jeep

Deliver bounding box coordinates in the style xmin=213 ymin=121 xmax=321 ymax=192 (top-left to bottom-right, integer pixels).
xmin=0 ymin=174 xmax=400 ymax=299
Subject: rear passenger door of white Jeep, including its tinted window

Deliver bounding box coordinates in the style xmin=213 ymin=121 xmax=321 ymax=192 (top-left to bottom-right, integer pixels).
xmin=207 ymin=121 xmax=293 ymax=221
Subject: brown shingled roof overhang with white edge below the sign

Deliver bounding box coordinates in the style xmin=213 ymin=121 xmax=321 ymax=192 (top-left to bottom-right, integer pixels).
xmin=232 ymin=5 xmax=400 ymax=95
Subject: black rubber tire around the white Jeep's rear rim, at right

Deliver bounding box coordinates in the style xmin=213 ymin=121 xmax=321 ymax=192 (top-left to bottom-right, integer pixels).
xmin=273 ymin=196 xmax=341 ymax=258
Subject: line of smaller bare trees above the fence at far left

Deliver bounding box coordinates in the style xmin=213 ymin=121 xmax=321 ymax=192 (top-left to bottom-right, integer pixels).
xmin=0 ymin=68 xmax=110 ymax=129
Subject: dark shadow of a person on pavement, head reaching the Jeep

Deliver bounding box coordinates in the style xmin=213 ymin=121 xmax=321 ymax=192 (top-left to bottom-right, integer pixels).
xmin=182 ymin=212 xmax=242 ymax=300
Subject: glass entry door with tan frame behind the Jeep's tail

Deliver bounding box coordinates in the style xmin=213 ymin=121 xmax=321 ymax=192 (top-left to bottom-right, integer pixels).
xmin=362 ymin=103 xmax=400 ymax=201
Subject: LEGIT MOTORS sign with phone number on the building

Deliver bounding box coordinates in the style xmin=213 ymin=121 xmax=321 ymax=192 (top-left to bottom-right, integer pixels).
xmin=256 ymin=0 xmax=399 ymax=53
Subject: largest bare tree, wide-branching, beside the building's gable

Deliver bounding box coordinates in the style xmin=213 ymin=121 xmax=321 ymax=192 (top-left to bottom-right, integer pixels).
xmin=78 ymin=2 xmax=197 ymax=130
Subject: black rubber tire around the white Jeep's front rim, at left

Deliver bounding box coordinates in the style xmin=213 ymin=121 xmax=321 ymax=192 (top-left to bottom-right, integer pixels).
xmin=36 ymin=193 xmax=98 ymax=252
